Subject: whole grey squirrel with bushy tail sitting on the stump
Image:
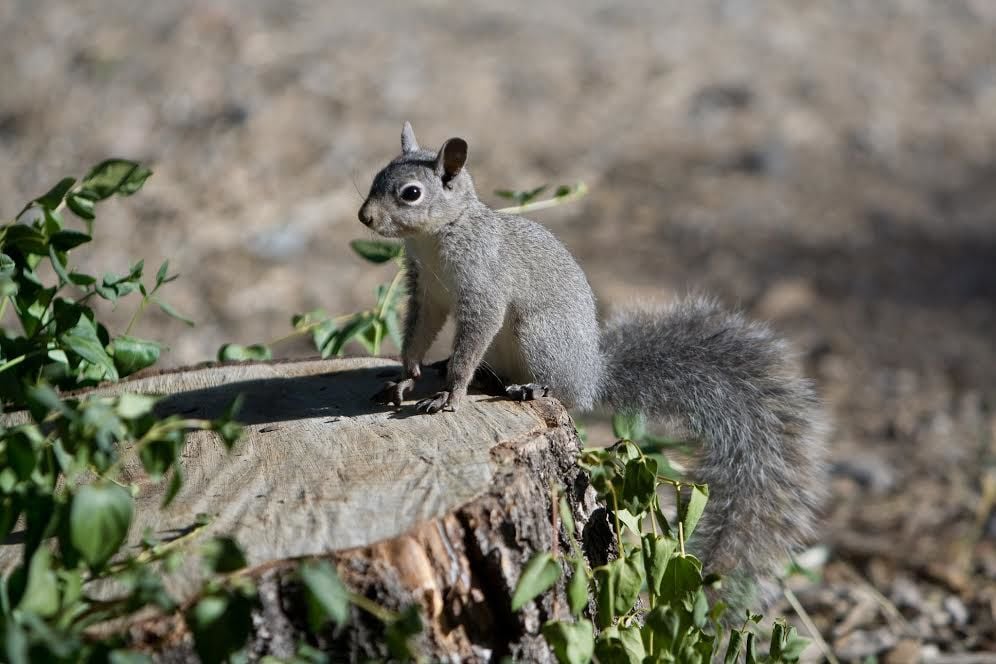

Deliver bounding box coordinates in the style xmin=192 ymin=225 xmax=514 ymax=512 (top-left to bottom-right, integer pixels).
xmin=359 ymin=123 xmax=825 ymax=599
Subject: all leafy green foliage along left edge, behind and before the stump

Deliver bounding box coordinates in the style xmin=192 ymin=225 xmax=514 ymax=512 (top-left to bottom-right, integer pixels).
xmin=0 ymin=159 xmax=253 ymax=663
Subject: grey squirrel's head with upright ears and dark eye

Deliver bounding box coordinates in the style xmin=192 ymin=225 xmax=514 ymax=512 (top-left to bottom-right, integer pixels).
xmin=359 ymin=122 xmax=477 ymax=237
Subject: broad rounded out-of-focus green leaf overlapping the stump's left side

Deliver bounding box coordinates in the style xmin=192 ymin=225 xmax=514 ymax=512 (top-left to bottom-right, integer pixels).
xmin=69 ymin=483 xmax=133 ymax=569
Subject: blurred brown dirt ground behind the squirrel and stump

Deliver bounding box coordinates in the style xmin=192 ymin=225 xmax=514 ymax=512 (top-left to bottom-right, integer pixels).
xmin=0 ymin=0 xmax=996 ymax=663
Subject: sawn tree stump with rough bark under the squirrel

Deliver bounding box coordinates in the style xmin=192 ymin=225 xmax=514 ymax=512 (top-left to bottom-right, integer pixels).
xmin=0 ymin=359 xmax=611 ymax=662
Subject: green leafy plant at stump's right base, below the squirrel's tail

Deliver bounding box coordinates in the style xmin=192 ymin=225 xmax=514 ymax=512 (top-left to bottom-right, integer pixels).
xmin=512 ymin=416 xmax=808 ymax=664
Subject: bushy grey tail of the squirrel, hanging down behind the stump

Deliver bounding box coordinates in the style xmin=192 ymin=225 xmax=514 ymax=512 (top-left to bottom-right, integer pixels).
xmin=601 ymin=298 xmax=826 ymax=601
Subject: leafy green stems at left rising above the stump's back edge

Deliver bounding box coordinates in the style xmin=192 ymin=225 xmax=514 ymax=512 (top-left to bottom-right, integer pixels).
xmin=0 ymin=159 xmax=196 ymax=406
